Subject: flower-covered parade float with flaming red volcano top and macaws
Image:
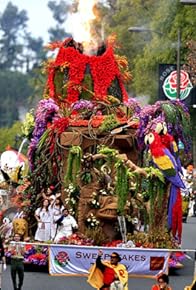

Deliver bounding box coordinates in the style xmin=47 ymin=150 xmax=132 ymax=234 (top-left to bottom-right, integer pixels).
xmin=0 ymin=0 xmax=190 ymax=275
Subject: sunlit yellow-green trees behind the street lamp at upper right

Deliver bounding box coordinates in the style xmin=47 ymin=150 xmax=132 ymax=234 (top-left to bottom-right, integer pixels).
xmin=103 ymin=0 xmax=196 ymax=103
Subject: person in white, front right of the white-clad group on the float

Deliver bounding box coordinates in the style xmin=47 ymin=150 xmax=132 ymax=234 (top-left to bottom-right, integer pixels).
xmin=54 ymin=208 xmax=78 ymax=243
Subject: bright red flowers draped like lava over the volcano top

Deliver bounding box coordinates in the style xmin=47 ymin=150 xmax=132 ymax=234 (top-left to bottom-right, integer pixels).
xmin=47 ymin=46 xmax=128 ymax=104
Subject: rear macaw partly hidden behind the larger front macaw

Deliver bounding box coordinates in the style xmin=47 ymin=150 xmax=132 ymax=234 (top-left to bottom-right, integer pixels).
xmin=155 ymin=122 xmax=183 ymax=175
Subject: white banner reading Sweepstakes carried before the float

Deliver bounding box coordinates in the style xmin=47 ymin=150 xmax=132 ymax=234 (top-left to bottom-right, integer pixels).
xmin=49 ymin=245 xmax=170 ymax=277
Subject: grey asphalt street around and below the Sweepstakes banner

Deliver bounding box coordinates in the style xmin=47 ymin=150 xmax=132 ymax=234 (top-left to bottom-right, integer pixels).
xmin=2 ymin=217 xmax=196 ymax=290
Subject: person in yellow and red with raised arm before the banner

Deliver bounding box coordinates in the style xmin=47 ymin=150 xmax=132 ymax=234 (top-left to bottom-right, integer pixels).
xmin=88 ymin=250 xmax=128 ymax=290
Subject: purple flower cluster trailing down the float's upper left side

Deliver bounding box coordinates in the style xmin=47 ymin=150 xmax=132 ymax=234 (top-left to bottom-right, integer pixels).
xmin=28 ymin=99 xmax=59 ymax=169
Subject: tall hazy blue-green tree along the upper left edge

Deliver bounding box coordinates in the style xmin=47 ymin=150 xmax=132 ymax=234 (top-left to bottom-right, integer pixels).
xmin=0 ymin=2 xmax=47 ymax=127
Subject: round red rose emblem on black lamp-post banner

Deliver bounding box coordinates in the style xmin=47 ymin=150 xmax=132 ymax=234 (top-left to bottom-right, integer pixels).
xmin=163 ymin=70 xmax=193 ymax=100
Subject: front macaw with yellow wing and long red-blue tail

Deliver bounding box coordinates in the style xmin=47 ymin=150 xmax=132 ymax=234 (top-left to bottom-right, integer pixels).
xmin=145 ymin=132 xmax=185 ymax=242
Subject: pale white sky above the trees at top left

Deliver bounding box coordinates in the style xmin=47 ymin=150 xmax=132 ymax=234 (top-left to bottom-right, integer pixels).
xmin=0 ymin=0 xmax=55 ymax=43
